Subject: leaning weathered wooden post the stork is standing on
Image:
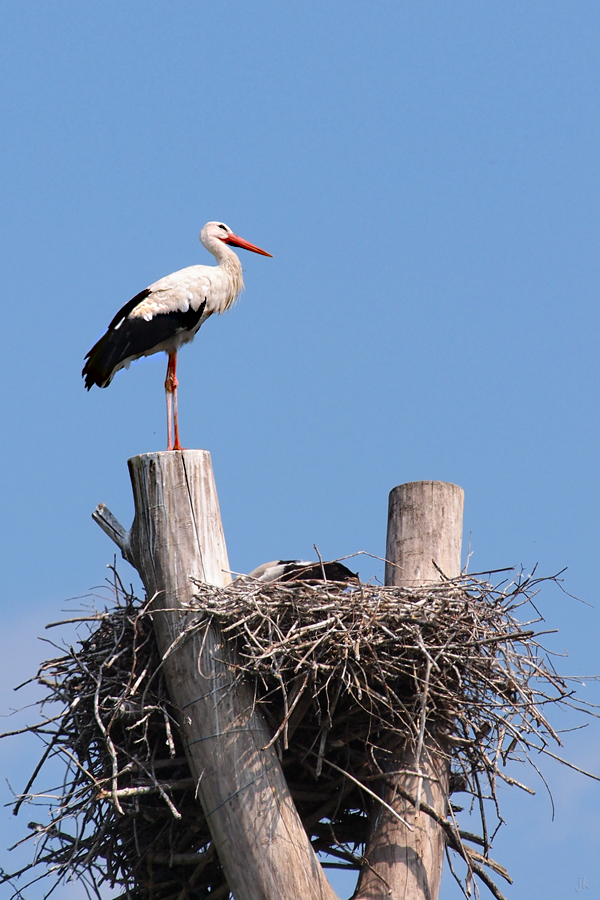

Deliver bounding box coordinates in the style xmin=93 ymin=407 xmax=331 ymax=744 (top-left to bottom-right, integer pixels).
xmin=94 ymin=450 xmax=335 ymax=900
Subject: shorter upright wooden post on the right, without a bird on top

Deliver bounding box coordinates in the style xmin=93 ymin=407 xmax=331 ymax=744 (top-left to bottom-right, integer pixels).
xmin=356 ymin=481 xmax=464 ymax=900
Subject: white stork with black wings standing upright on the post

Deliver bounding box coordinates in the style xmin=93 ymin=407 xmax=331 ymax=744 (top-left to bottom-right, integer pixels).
xmin=81 ymin=222 xmax=271 ymax=450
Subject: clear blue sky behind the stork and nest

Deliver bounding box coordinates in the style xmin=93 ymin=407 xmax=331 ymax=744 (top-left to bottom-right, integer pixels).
xmin=0 ymin=0 xmax=600 ymax=900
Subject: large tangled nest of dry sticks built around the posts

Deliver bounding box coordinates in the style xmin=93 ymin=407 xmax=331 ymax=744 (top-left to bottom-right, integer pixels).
xmin=0 ymin=573 xmax=587 ymax=900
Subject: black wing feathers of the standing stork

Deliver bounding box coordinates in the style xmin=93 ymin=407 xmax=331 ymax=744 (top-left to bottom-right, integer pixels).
xmin=81 ymin=289 xmax=206 ymax=391
